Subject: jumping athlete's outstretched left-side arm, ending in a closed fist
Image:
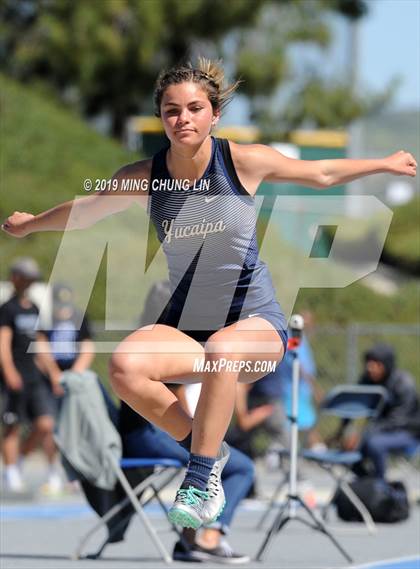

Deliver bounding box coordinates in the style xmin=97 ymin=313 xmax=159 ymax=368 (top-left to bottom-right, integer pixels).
xmin=1 ymin=160 xmax=148 ymax=237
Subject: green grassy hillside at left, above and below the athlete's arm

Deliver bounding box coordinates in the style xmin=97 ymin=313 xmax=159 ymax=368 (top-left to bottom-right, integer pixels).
xmin=0 ymin=75 xmax=139 ymax=317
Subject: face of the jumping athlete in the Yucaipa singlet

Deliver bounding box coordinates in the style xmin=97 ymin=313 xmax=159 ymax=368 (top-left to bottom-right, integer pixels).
xmin=160 ymin=82 xmax=219 ymax=144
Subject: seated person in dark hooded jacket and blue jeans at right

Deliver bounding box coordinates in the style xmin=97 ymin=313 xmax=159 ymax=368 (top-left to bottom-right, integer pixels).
xmin=333 ymin=344 xmax=420 ymax=478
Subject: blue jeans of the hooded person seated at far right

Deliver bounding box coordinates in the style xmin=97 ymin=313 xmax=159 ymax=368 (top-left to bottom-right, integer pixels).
xmin=360 ymin=430 xmax=417 ymax=478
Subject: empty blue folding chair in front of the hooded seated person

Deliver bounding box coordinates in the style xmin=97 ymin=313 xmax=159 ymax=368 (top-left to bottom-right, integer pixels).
xmin=301 ymin=385 xmax=387 ymax=533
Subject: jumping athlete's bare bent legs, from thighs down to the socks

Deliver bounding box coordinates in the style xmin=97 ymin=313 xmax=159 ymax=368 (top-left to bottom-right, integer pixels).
xmin=110 ymin=317 xmax=283 ymax=450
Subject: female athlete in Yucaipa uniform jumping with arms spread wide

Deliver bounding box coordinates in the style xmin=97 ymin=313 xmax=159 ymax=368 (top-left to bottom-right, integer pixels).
xmin=3 ymin=59 xmax=417 ymax=528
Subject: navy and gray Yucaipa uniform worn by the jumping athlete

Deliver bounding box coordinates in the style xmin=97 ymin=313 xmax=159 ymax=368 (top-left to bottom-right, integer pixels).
xmin=148 ymin=137 xmax=287 ymax=343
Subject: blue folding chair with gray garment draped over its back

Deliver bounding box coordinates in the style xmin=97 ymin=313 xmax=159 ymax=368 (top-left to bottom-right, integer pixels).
xmin=54 ymin=371 xmax=183 ymax=563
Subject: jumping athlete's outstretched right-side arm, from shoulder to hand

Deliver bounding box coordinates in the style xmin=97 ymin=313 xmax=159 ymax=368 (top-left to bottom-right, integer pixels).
xmin=232 ymin=144 xmax=417 ymax=194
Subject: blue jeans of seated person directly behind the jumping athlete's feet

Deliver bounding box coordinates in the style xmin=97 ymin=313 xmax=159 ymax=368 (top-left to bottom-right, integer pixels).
xmin=122 ymin=424 xmax=255 ymax=534
